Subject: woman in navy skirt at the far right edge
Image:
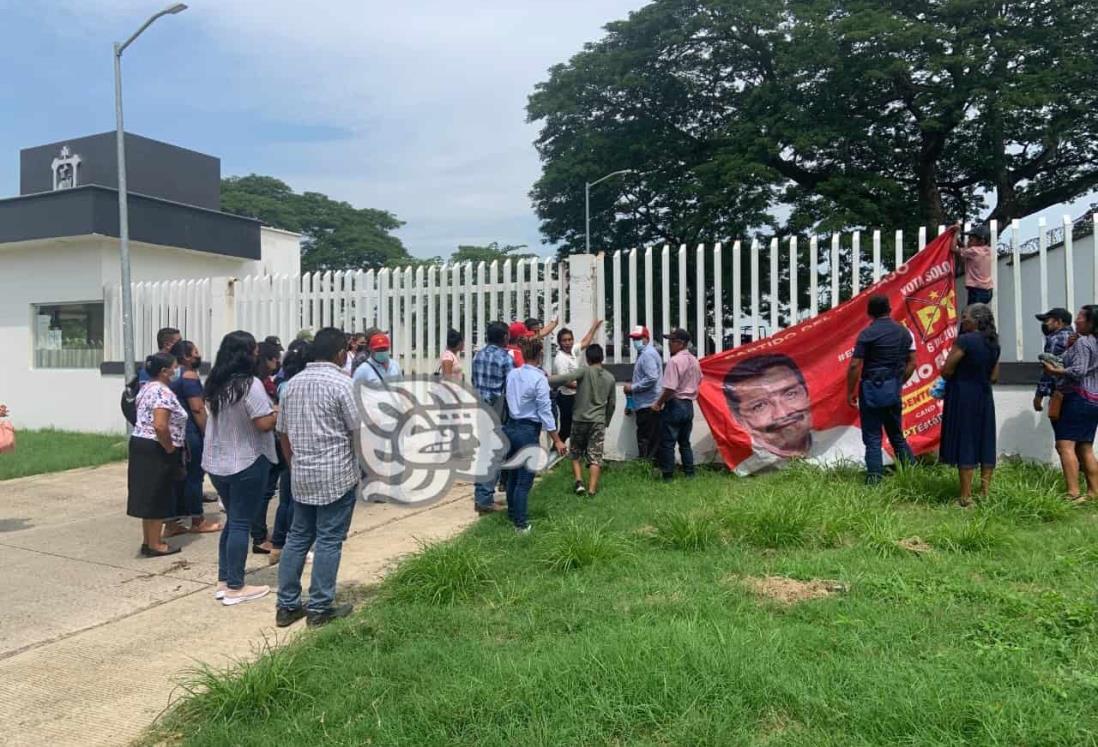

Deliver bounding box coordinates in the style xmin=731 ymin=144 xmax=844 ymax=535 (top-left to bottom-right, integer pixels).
xmin=1044 ymin=304 xmax=1098 ymax=502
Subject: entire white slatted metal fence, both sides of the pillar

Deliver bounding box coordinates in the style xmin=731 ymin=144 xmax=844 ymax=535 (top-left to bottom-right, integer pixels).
xmin=104 ymin=214 xmax=1098 ymax=374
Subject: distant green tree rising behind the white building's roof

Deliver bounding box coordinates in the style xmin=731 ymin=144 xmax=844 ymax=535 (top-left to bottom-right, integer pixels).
xmin=221 ymin=174 xmax=413 ymax=272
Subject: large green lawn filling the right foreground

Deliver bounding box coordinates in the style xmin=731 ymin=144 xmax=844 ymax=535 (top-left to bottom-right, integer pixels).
xmin=149 ymin=462 xmax=1098 ymax=747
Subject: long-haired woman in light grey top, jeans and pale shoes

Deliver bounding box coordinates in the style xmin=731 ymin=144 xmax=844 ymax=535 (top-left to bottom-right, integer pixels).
xmin=202 ymin=331 xmax=277 ymax=605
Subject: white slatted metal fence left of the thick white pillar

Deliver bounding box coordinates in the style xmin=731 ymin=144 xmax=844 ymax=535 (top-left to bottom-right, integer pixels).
xmin=104 ymin=258 xmax=568 ymax=374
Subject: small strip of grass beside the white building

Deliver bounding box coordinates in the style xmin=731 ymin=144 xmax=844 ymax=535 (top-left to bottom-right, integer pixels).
xmin=0 ymin=430 xmax=127 ymax=480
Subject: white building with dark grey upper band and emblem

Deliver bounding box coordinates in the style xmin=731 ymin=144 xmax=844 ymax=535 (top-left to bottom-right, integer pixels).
xmin=0 ymin=132 xmax=301 ymax=432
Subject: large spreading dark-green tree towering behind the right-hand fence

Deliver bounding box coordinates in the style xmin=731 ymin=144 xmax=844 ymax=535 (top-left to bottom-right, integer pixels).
xmin=528 ymin=0 xmax=1098 ymax=252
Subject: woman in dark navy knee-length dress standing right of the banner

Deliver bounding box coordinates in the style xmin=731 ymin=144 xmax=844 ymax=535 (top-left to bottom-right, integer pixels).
xmin=939 ymin=303 xmax=999 ymax=506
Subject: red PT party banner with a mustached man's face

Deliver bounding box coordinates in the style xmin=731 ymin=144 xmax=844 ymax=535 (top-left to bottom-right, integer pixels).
xmin=698 ymin=228 xmax=957 ymax=475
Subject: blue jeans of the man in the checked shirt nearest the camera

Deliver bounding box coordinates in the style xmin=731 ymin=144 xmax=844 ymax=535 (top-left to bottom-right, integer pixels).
xmin=278 ymin=488 xmax=356 ymax=613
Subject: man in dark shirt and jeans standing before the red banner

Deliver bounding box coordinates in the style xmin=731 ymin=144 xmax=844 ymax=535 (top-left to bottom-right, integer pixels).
xmin=847 ymin=296 xmax=915 ymax=484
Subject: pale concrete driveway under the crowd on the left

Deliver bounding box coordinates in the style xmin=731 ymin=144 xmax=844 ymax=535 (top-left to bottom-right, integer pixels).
xmin=0 ymin=464 xmax=475 ymax=745
